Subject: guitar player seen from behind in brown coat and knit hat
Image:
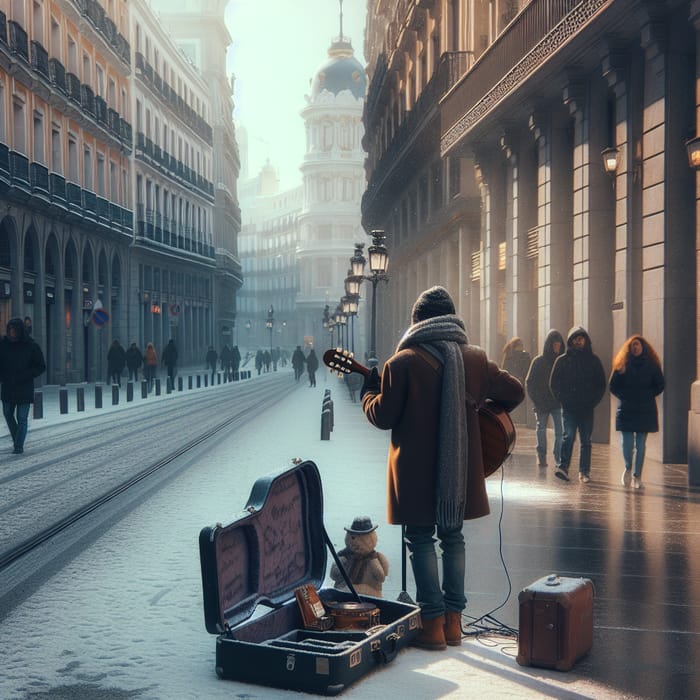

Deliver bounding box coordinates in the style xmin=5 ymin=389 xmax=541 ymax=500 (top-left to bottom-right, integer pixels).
xmin=361 ymin=287 xmax=524 ymax=649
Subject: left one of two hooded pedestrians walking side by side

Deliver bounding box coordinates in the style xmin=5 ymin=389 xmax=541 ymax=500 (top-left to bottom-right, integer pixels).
xmin=525 ymin=328 xmax=564 ymax=469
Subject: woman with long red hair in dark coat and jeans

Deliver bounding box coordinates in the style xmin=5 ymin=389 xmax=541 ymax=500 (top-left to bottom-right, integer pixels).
xmin=610 ymin=335 xmax=664 ymax=489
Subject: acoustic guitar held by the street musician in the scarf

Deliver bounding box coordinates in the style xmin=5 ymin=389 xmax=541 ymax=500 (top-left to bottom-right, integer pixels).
xmin=323 ymin=348 xmax=515 ymax=477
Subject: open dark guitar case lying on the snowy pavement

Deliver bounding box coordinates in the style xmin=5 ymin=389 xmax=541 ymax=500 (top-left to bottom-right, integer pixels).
xmin=199 ymin=461 xmax=420 ymax=695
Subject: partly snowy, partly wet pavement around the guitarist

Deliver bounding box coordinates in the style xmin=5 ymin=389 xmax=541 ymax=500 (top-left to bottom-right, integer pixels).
xmin=0 ymin=373 xmax=700 ymax=700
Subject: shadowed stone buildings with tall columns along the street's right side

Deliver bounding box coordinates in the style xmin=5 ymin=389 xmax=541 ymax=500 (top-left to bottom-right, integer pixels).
xmin=363 ymin=0 xmax=700 ymax=474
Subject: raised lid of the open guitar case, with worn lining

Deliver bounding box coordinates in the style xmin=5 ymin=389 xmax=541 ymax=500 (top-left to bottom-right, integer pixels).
xmin=199 ymin=461 xmax=327 ymax=634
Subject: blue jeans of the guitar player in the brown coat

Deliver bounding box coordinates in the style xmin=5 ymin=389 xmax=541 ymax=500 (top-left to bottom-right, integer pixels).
xmin=406 ymin=525 xmax=467 ymax=620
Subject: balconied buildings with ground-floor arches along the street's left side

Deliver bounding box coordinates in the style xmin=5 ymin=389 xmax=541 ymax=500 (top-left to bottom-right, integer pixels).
xmin=0 ymin=0 xmax=241 ymax=383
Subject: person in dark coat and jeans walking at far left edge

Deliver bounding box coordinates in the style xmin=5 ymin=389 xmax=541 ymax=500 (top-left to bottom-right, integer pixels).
xmin=0 ymin=318 xmax=46 ymax=454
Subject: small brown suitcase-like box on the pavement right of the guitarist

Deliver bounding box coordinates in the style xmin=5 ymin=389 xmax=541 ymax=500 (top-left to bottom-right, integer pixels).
xmin=516 ymin=574 xmax=594 ymax=671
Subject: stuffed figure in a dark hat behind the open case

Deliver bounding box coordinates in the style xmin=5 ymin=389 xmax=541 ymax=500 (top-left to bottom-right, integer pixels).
xmin=331 ymin=516 xmax=389 ymax=598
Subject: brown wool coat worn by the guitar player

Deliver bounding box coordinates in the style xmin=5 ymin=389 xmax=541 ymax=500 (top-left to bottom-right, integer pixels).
xmin=362 ymin=345 xmax=525 ymax=525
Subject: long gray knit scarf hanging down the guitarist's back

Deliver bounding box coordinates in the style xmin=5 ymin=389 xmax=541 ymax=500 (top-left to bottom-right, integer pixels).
xmin=396 ymin=315 xmax=469 ymax=530
